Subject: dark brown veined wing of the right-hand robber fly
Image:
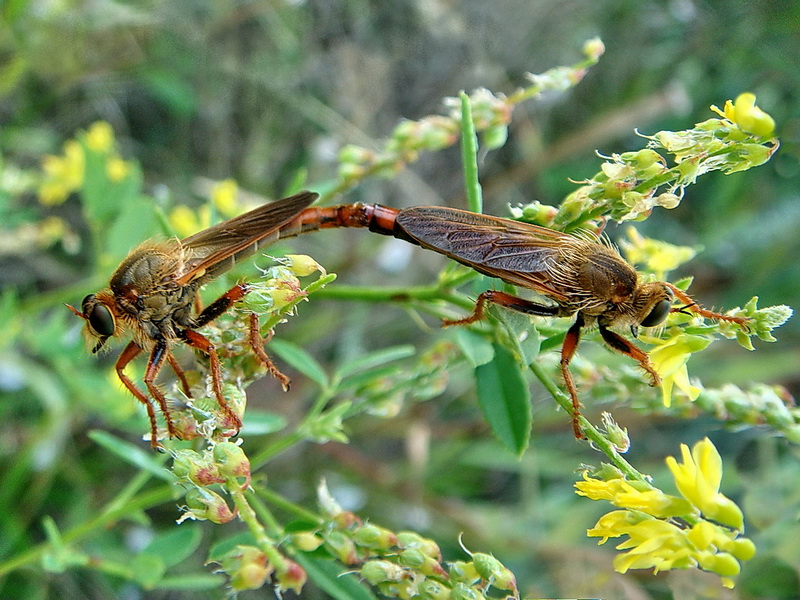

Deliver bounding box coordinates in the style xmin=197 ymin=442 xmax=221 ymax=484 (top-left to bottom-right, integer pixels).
xmin=397 ymin=206 xmax=574 ymax=300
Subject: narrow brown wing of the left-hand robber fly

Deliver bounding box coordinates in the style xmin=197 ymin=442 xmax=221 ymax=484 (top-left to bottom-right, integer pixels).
xmin=177 ymin=192 xmax=318 ymax=285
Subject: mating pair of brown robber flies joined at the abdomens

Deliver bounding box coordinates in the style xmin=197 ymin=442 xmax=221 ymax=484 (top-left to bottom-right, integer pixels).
xmin=69 ymin=192 xmax=747 ymax=447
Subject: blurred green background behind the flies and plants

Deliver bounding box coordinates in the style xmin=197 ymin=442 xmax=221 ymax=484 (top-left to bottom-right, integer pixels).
xmin=0 ymin=0 xmax=800 ymax=598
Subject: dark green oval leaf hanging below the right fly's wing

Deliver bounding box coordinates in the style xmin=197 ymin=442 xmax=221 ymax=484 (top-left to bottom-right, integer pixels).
xmin=475 ymin=344 xmax=532 ymax=456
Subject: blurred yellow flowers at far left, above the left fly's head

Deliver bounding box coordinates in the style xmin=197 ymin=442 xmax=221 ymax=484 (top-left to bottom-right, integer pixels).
xmin=39 ymin=121 xmax=131 ymax=206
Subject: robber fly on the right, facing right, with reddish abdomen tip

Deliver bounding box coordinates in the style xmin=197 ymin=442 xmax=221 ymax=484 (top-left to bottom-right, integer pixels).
xmin=280 ymin=204 xmax=747 ymax=438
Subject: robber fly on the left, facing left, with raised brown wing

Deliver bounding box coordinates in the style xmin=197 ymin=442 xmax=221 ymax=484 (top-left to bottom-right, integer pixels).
xmin=67 ymin=192 xmax=317 ymax=448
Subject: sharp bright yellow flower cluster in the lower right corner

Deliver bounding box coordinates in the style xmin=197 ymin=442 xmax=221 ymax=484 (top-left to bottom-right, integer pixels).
xmin=575 ymin=438 xmax=755 ymax=587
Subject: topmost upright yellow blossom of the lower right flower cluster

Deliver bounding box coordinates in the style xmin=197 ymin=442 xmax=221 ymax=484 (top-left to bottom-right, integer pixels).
xmin=667 ymin=438 xmax=744 ymax=531
